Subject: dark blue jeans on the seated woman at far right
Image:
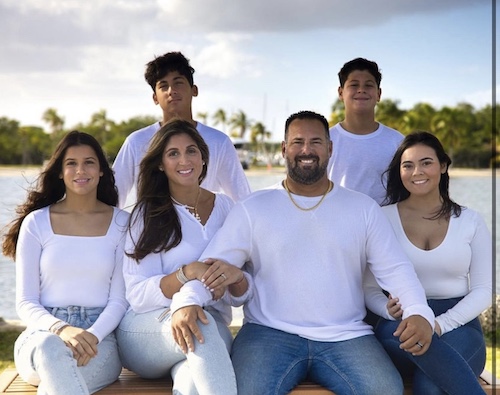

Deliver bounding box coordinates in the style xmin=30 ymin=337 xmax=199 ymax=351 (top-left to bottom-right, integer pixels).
xmin=375 ymin=298 xmax=486 ymax=395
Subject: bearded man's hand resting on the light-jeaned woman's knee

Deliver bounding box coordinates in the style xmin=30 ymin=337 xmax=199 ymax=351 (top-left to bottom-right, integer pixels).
xmin=172 ymin=305 xmax=208 ymax=353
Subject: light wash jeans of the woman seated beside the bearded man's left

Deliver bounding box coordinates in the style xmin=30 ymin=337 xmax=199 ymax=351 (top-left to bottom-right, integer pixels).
xmin=116 ymin=308 xmax=236 ymax=395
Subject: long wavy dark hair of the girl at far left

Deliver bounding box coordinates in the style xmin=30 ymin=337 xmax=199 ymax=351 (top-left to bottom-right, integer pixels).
xmin=2 ymin=130 xmax=118 ymax=258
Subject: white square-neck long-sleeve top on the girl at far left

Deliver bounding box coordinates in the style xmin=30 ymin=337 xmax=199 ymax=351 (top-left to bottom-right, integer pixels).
xmin=16 ymin=207 xmax=129 ymax=341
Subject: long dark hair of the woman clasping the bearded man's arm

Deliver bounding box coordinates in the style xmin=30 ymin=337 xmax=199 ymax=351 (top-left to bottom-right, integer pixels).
xmin=126 ymin=119 xmax=209 ymax=261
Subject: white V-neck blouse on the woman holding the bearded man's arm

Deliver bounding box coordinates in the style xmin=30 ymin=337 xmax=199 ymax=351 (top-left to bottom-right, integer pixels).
xmin=123 ymin=194 xmax=248 ymax=323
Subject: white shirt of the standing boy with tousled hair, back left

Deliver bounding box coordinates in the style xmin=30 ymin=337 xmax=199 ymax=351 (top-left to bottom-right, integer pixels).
xmin=113 ymin=122 xmax=250 ymax=208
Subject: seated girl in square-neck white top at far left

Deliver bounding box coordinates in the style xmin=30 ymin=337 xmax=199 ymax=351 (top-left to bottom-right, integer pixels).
xmin=3 ymin=131 xmax=128 ymax=395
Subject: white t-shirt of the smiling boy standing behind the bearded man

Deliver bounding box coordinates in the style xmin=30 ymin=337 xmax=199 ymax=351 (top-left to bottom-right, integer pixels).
xmin=328 ymin=123 xmax=404 ymax=204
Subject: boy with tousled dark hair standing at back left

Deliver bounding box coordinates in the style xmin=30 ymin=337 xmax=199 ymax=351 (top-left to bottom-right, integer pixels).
xmin=113 ymin=52 xmax=250 ymax=208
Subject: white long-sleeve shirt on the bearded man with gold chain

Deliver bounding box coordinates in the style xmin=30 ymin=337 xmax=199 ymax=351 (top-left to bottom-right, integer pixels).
xmin=201 ymin=184 xmax=434 ymax=341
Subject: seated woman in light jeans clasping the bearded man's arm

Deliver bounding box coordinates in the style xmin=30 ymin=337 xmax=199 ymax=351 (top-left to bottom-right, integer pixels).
xmin=117 ymin=119 xmax=249 ymax=395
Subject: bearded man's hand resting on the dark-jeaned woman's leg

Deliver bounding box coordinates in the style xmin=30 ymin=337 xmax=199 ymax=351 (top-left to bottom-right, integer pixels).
xmin=394 ymin=315 xmax=432 ymax=355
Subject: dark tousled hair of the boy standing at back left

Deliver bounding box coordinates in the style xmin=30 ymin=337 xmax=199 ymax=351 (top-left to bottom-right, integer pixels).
xmin=144 ymin=52 xmax=194 ymax=92
